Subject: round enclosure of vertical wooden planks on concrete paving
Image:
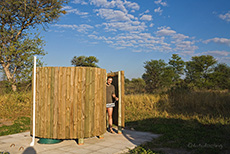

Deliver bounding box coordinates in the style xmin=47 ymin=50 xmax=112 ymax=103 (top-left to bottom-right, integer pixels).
xmin=30 ymin=67 xmax=124 ymax=142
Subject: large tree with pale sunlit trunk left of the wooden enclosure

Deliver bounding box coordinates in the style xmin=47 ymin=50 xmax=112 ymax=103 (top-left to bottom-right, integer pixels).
xmin=0 ymin=0 xmax=67 ymax=91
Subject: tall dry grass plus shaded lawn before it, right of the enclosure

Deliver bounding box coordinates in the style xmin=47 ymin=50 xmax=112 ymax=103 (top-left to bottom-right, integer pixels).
xmin=125 ymin=91 xmax=230 ymax=154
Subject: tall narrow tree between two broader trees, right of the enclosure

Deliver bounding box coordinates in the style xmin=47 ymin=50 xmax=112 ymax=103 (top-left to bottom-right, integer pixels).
xmin=169 ymin=54 xmax=185 ymax=82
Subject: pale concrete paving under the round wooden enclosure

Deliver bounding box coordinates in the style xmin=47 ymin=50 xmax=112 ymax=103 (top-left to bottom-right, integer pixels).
xmin=0 ymin=129 xmax=159 ymax=154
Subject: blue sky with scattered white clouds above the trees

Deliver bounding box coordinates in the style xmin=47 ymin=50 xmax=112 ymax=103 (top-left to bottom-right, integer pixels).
xmin=38 ymin=0 xmax=230 ymax=79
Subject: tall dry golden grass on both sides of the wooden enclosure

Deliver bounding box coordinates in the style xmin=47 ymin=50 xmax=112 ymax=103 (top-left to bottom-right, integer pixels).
xmin=0 ymin=91 xmax=230 ymax=124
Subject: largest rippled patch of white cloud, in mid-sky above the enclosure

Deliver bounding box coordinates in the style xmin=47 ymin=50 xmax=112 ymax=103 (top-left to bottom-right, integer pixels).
xmin=58 ymin=0 xmax=198 ymax=54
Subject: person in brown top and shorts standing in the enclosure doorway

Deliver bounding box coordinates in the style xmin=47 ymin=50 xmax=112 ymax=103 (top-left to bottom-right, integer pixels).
xmin=106 ymin=77 xmax=118 ymax=133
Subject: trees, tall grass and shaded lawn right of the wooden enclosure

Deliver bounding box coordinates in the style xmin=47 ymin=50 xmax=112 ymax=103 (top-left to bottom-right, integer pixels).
xmin=125 ymin=54 xmax=230 ymax=154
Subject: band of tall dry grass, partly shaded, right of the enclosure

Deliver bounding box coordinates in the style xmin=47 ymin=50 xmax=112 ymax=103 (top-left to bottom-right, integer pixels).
xmin=125 ymin=91 xmax=230 ymax=124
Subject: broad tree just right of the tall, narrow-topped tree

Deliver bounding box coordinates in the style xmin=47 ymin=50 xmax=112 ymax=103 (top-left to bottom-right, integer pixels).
xmin=185 ymin=55 xmax=217 ymax=88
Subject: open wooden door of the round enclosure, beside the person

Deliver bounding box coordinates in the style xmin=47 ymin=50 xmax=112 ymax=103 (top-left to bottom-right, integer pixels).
xmin=107 ymin=71 xmax=125 ymax=134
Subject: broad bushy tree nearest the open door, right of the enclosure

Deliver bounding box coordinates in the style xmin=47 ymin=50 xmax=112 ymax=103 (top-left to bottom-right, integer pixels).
xmin=142 ymin=59 xmax=174 ymax=93
